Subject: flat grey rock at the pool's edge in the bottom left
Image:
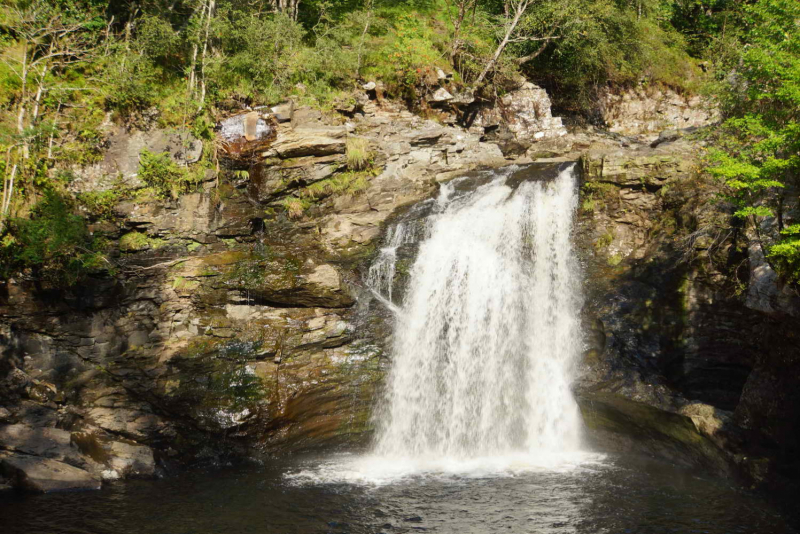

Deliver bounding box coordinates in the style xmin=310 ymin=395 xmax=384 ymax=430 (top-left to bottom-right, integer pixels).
xmin=0 ymin=454 xmax=101 ymax=493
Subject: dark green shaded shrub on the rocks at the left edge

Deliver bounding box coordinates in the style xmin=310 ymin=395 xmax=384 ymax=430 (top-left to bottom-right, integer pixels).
xmin=0 ymin=189 xmax=108 ymax=285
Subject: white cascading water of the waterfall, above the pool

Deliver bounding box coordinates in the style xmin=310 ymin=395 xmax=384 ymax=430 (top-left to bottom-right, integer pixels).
xmin=376 ymin=166 xmax=581 ymax=459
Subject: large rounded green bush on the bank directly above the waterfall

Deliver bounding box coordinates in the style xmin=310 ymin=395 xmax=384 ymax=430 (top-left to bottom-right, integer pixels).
xmin=515 ymin=0 xmax=700 ymax=113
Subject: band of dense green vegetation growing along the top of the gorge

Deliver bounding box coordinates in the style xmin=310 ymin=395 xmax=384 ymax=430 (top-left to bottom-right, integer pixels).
xmin=0 ymin=0 xmax=800 ymax=279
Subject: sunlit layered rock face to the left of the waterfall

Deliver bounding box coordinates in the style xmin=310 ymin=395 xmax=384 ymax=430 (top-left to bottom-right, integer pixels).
xmin=0 ymin=91 xmax=536 ymax=491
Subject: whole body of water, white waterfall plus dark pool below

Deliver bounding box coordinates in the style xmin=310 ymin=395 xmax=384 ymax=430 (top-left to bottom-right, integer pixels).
xmin=0 ymin=166 xmax=795 ymax=534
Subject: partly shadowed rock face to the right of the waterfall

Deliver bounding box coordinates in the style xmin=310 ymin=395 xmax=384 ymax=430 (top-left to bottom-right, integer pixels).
xmin=576 ymin=140 xmax=800 ymax=492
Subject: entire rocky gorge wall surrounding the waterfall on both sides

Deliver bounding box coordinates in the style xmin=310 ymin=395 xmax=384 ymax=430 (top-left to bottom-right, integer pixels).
xmin=0 ymin=81 xmax=800 ymax=500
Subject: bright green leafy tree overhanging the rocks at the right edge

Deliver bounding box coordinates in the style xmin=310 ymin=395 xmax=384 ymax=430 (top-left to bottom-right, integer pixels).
xmin=709 ymin=0 xmax=800 ymax=282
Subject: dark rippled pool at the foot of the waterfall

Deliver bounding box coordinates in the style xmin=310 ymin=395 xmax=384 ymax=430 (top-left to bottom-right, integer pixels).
xmin=0 ymin=457 xmax=796 ymax=534
